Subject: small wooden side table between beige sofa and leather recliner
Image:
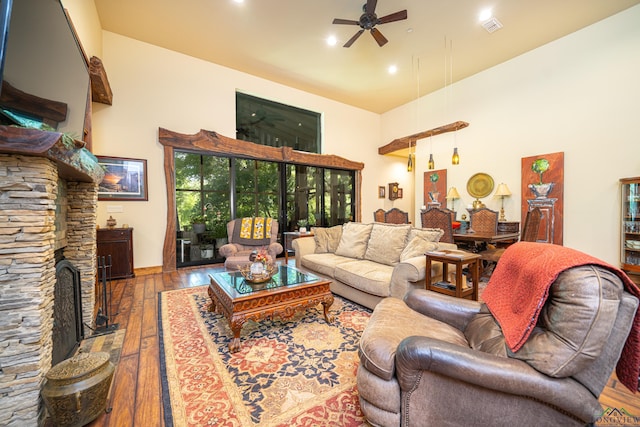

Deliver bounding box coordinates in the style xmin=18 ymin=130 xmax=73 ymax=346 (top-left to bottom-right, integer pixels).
xmin=425 ymin=250 xmax=480 ymax=301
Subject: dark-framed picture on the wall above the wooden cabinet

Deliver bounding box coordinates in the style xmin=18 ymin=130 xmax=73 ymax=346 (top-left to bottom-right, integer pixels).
xmin=96 ymin=156 xmax=148 ymax=200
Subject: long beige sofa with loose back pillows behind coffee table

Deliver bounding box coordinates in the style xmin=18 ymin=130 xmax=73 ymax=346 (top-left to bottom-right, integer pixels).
xmin=292 ymin=222 xmax=456 ymax=309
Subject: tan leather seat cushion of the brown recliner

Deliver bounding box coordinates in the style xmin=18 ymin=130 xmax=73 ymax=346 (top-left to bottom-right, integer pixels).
xmin=358 ymin=297 xmax=468 ymax=381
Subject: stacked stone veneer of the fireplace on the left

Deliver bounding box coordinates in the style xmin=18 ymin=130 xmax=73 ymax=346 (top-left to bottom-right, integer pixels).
xmin=0 ymin=154 xmax=97 ymax=426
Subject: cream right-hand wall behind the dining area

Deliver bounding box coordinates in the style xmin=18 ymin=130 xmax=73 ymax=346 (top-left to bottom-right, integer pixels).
xmin=382 ymin=6 xmax=640 ymax=265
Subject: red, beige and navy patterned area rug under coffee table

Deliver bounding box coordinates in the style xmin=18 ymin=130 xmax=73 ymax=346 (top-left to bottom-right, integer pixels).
xmin=158 ymin=286 xmax=371 ymax=427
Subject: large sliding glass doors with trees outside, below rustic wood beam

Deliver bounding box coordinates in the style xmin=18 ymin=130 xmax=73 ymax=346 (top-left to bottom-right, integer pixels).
xmin=174 ymin=151 xmax=355 ymax=267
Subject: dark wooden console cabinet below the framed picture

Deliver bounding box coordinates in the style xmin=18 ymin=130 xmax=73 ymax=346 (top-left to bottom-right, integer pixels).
xmin=97 ymin=228 xmax=134 ymax=279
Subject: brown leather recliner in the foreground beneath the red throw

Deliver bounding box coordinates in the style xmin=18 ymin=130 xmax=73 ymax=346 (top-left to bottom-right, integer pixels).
xmin=357 ymin=265 xmax=638 ymax=426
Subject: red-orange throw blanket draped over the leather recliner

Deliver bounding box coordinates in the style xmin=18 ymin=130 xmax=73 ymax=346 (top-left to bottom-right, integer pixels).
xmin=482 ymin=242 xmax=640 ymax=393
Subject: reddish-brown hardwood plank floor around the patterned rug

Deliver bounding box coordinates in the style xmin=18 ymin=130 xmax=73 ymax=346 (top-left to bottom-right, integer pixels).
xmin=89 ymin=267 xmax=640 ymax=427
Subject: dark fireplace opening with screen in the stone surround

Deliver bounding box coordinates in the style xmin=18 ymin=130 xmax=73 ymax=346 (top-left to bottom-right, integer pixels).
xmin=51 ymin=257 xmax=84 ymax=366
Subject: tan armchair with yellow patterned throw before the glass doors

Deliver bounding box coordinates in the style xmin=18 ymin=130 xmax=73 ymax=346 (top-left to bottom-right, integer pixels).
xmin=220 ymin=217 xmax=283 ymax=270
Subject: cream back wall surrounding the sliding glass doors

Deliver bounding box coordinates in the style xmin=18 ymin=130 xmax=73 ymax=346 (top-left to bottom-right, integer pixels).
xmin=93 ymin=32 xmax=402 ymax=268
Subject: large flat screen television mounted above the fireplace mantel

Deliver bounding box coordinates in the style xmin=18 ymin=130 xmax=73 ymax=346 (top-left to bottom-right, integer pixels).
xmin=0 ymin=0 xmax=91 ymax=140
